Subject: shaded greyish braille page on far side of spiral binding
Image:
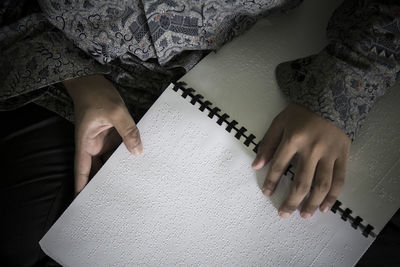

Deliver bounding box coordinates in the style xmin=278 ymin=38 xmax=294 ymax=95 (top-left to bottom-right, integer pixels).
xmin=181 ymin=0 xmax=400 ymax=233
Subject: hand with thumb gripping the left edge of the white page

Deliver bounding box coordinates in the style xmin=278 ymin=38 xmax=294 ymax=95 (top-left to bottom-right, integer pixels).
xmin=63 ymin=75 xmax=143 ymax=195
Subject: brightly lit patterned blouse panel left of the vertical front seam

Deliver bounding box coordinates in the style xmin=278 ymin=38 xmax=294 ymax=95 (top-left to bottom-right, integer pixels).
xmin=38 ymin=0 xmax=157 ymax=64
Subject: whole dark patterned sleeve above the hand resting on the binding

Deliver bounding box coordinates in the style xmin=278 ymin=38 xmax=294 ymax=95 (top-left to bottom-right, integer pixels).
xmin=276 ymin=0 xmax=400 ymax=141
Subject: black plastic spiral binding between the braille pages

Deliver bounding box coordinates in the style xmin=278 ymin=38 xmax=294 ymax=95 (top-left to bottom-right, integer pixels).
xmin=172 ymin=82 xmax=376 ymax=237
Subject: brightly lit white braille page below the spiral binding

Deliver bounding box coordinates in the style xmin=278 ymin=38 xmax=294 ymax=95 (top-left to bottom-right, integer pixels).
xmin=40 ymin=85 xmax=373 ymax=266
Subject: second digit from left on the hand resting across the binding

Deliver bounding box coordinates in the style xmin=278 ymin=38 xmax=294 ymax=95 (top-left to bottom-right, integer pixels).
xmin=262 ymin=137 xmax=296 ymax=196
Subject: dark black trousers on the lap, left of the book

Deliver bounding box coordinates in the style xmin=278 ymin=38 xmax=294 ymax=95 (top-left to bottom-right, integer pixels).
xmin=0 ymin=104 xmax=74 ymax=266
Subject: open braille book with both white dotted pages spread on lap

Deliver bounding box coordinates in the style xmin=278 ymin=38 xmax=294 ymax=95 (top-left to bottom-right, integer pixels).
xmin=40 ymin=0 xmax=400 ymax=266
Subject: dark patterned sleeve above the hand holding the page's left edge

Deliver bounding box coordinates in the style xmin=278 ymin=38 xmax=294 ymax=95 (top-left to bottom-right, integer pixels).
xmin=0 ymin=4 xmax=109 ymax=114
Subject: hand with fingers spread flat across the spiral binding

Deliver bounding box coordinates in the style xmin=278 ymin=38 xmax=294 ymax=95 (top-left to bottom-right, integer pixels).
xmin=252 ymin=104 xmax=351 ymax=218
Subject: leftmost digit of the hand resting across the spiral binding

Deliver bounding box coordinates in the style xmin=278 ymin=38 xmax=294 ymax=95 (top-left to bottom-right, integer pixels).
xmin=251 ymin=116 xmax=283 ymax=170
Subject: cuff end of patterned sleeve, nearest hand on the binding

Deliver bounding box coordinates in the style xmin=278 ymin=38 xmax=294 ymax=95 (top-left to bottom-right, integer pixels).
xmin=276 ymin=49 xmax=395 ymax=141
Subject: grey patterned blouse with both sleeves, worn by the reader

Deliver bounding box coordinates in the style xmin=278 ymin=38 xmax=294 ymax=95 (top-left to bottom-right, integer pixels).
xmin=0 ymin=0 xmax=400 ymax=140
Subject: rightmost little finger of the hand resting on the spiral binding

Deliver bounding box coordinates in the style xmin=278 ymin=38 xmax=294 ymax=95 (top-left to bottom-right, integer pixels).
xmin=320 ymin=158 xmax=347 ymax=212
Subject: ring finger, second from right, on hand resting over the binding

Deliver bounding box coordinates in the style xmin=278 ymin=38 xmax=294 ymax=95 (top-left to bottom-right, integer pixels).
xmin=300 ymin=159 xmax=334 ymax=219
